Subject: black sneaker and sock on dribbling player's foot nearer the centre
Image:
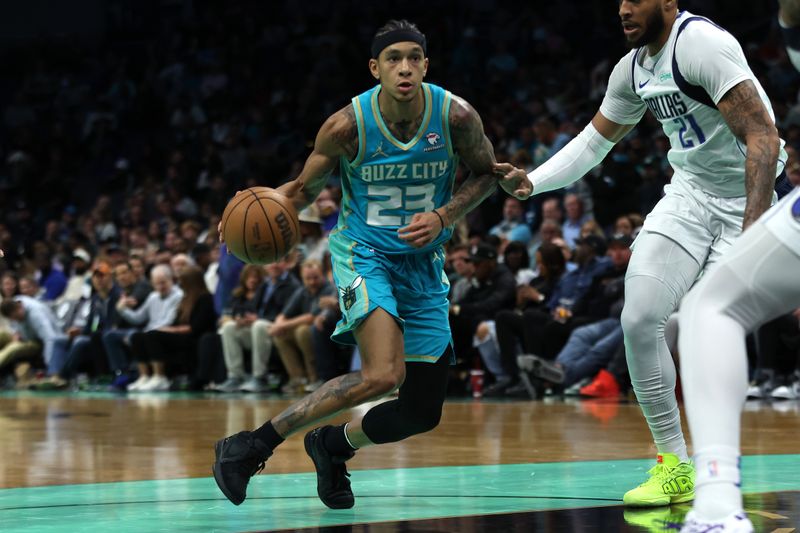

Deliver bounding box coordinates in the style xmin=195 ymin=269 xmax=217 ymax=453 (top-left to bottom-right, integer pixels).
xmin=305 ymin=426 xmax=355 ymax=509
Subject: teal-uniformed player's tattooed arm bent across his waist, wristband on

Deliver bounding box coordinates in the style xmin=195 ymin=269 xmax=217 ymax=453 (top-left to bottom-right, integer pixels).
xmin=398 ymin=96 xmax=498 ymax=248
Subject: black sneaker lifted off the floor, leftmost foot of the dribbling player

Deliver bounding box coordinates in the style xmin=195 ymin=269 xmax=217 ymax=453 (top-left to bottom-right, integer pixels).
xmin=211 ymin=431 xmax=272 ymax=505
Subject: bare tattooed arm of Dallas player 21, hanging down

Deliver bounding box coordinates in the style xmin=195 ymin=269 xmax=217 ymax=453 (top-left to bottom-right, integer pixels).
xmin=717 ymin=80 xmax=780 ymax=229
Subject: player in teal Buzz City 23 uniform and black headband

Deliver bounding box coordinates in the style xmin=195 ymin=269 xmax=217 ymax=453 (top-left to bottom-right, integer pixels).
xmin=213 ymin=20 xmax=497 ymax=509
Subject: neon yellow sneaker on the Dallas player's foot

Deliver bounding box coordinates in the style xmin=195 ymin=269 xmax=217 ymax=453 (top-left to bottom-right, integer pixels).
xmin=622 ymin=453 xmax=694 ymax=507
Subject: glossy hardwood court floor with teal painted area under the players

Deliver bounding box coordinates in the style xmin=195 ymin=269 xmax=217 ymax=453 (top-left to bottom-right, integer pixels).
xmin=0 ymin=393 xmax=800 ymax=533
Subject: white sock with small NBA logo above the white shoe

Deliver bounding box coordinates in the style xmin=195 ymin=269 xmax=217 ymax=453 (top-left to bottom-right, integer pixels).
xmin=694 ymin=446 xmax=743 ymax=520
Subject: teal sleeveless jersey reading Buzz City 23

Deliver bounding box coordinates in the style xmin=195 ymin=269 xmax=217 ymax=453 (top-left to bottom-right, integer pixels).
xmin=337 ymin=83 xmax=458 ymax=254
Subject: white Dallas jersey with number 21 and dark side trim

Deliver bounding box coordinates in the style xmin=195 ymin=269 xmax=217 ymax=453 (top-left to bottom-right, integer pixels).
xmin=600 ymin=11 xmax=786 ymax=198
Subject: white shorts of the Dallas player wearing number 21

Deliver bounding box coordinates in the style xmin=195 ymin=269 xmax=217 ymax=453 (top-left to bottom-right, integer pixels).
xmin=631 ymin=179 xmax=772 ymax=267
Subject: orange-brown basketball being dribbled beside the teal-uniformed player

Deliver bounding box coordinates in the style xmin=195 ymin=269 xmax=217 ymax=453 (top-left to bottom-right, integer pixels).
xmin=222 ymin=187 xmax=300 ymax=265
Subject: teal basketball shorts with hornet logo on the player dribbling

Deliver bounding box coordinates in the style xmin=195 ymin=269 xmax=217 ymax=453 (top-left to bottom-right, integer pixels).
xmin=328 ymin=232 xmax=452 ymax=363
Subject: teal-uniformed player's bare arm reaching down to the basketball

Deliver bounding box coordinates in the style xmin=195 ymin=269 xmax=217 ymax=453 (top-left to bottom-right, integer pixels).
xmin=278 ymin=104 xmax=358 ymax=211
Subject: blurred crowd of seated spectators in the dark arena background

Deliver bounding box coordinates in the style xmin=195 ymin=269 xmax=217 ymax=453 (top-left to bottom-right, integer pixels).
xmin=0 ymin=0 xmax=800 ymax=398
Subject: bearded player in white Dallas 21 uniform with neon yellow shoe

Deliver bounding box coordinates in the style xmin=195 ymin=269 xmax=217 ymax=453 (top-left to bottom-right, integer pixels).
xmin=496 ymin=0 xmax=785 ymax=516
